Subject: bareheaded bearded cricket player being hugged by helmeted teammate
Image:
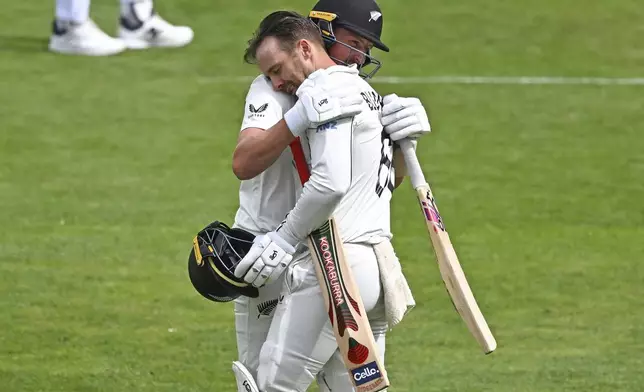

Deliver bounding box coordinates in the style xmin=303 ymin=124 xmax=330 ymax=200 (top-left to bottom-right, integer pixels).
xmin=229 ymin=9 xmax=429 ymax=392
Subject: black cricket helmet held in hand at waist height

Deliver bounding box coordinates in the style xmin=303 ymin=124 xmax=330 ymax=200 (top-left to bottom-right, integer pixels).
xmin=188 ymin=221 xmax=259 ymax=302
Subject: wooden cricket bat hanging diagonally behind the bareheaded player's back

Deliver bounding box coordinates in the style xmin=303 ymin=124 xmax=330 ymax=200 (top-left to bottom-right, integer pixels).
xmin=400 ymin=141 xmax=496 ymax=354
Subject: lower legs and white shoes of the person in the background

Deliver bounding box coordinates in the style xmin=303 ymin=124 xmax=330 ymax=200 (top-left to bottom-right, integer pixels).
xmin=49 ymin=0 xmax=194 ymax=56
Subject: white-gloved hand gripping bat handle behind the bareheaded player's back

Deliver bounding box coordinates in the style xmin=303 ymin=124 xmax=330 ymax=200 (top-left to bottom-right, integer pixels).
xmin=381 ymin=94 xmax=432 ymax=141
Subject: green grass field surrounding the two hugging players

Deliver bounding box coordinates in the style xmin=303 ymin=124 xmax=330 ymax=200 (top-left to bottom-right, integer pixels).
xmin=0 ymin=0 xmax=644 ymax=392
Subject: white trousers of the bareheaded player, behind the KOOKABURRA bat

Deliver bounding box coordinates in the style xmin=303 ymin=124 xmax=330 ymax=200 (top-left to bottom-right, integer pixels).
xmin=257 ymin=244 xmax=387 ymax=392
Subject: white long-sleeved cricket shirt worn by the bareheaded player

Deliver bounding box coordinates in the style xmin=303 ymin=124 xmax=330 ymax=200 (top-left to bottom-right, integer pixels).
xmin=279 ymin=66 xmax=394 ymax=244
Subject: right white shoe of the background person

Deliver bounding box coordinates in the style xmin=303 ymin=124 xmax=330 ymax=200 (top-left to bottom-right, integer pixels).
xmin=119 ymin=13 xmax=194 ymax=49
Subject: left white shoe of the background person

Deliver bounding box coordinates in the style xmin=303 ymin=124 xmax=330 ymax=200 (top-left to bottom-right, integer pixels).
xmin=49 ymin=19 xmax=126 ymax=56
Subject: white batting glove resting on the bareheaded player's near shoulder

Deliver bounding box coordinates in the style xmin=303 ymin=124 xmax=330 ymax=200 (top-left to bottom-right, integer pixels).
xmin=284 ymin=69 xmax=364 ymax=137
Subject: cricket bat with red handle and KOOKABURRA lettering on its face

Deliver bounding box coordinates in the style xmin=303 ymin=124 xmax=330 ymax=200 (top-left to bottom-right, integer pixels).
xmin=291 ymin=139 xmax=389 ymax=392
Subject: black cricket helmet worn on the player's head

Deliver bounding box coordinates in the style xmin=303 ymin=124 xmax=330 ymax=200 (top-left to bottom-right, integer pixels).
xmin=309 ymin=0 xmax=389 ymax=79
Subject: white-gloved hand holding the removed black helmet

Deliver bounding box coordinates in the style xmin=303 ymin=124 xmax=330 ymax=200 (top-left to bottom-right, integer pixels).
xmin=235 ymin=231 xmax=295 ymax=287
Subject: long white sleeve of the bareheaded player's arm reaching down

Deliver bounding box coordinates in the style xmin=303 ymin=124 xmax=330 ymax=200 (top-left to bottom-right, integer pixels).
xmin=278 ymin=118 xmax=353 ymax=246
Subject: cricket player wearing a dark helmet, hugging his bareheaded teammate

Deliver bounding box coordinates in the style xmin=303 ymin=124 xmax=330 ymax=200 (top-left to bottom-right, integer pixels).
xmin=233 ymin=0 xmax=431 ymax=391
